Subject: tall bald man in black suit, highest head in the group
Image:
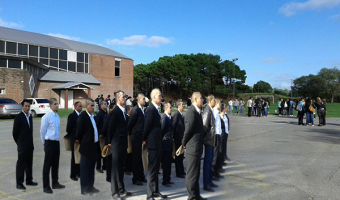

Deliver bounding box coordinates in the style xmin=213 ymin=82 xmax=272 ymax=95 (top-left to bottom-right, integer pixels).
xmin=143 ymin=88 xmax=167 ymax=200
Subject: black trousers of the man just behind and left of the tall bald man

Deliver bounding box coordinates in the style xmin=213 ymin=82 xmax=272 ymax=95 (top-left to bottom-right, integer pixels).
xmin=130 ymin=137 xmax=145 ymax=183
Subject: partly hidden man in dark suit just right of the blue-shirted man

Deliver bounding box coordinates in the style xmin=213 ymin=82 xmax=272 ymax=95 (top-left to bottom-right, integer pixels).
xmin=66 ymin=101 xmax=83 ymax=181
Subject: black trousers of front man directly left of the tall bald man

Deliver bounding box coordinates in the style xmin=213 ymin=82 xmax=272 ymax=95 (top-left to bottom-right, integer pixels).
xmin=111 ymin=148 xmax=126 ymax=195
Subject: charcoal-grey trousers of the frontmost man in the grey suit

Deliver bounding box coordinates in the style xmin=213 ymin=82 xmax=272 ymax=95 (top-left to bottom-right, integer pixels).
xmin=185 ymin=154 xmax=201 ymax=200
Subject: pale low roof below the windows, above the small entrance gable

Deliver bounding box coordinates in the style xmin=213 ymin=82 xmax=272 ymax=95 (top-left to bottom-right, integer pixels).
xmin=38 ymin=70 xmax=101 ymax=85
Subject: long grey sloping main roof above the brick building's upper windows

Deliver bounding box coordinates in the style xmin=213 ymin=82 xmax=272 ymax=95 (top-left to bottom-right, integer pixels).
xmin=0 ymin=26 xmax=132 ymax=60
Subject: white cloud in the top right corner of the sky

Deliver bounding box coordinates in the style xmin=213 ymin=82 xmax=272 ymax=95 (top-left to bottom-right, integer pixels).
xmin=279 ymin=0 xmax=340 ymax=17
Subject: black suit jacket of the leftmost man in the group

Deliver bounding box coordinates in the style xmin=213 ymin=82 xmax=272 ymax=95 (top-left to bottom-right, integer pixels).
xmin=13 ymin=112 xmax=34 ymax=152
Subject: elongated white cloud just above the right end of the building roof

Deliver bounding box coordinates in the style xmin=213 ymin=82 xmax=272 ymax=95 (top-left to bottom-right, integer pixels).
xmin=107 ymin=35 xmax=172 ymax=47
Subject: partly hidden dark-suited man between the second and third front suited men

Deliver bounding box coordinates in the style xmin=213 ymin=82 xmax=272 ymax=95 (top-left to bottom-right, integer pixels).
xmin=96 ymin=101 xmax=107 ymax=173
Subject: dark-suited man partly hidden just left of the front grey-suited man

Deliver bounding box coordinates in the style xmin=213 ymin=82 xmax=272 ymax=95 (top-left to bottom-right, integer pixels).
xmin=172 ymin=101 xmax=186 ymax=178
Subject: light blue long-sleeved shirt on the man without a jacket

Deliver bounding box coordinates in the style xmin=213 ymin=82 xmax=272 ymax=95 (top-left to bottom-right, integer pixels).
xmin=40 ymin=110 xmax=60 ymax=144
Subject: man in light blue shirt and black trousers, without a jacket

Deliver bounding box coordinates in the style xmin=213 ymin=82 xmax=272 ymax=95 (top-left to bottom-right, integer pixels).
xmin=40 ymin=98 xmax=65 ymax=194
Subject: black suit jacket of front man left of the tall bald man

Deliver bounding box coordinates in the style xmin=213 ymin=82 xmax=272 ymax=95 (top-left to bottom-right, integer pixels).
xmin=107 ymin=106 xmax=127 ymax=151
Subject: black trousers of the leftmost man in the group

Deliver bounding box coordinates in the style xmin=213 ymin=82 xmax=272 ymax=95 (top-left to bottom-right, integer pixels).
xmin=15 ymin=149 xmax=33 ymax=184
